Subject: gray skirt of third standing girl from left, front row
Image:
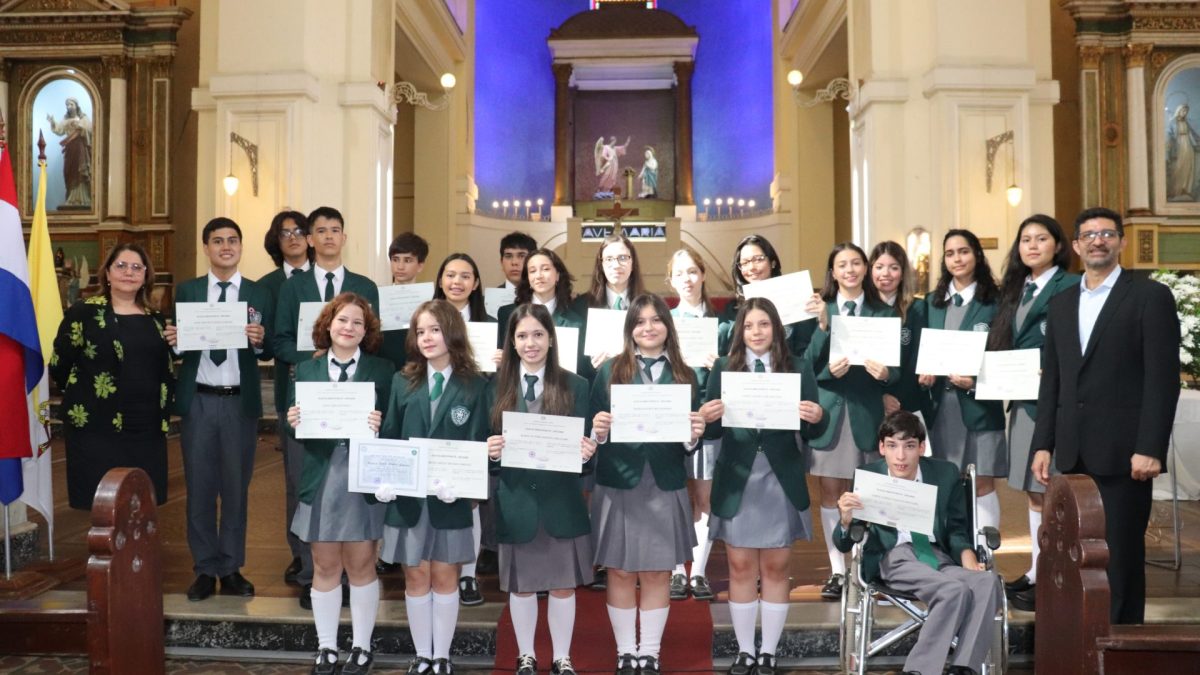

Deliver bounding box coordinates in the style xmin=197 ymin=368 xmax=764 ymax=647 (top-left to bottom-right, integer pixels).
xmin=499 ymin=525 xmax=594 ymax=593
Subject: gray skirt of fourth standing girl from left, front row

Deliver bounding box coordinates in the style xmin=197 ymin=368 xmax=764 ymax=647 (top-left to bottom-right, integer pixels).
xmin=590 ymin=462 xmax=696 ymax=572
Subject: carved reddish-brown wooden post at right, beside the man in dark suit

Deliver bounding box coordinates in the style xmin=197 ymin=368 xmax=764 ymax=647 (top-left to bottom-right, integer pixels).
xmin=1033 ymin=474 xmax=1109 ymax=674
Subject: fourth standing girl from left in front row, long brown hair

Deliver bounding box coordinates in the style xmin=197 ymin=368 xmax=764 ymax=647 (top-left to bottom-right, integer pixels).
xmin=592 ymin=293 xmax=704 ymax=675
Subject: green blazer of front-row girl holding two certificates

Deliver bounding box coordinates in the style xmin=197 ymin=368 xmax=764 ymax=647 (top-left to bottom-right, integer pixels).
xmin=379 ymin=370 xmax=488 ymax=530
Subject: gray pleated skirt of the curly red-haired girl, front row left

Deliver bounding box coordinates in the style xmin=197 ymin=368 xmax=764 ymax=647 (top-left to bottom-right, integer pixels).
xmin=292 ymin=444 xmax=388 ymax=543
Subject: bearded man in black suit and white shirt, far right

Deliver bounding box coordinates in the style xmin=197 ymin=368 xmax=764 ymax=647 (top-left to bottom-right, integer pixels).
xmin=1031 ymin=208 xmax=1180 ymax=623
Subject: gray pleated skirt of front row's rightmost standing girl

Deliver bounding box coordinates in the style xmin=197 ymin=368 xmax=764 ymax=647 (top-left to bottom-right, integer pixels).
xmin=708 ymin=453 xmax=812 ymax=549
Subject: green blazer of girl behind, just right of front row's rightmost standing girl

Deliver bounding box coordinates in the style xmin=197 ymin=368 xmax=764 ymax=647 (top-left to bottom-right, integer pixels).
xmin=806 ymin=297 xmax=901 ymax=453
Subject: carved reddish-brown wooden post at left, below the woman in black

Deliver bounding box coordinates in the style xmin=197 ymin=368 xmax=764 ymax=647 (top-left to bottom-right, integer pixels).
xmin=88 ymin=468 xmax=166 ymax=675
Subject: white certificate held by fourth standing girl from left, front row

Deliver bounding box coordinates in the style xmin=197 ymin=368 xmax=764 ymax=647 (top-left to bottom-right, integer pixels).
xmin=608 ymin=384 xmax=691 ymax=443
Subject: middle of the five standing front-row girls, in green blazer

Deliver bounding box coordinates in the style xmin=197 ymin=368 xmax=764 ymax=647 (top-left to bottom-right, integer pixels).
xmin=487 ymin=303 xmax=596 ymax=675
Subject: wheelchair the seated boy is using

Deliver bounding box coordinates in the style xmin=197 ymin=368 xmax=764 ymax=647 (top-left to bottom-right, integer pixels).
xmin=839 ymin=464 xmax=1008 ymax=675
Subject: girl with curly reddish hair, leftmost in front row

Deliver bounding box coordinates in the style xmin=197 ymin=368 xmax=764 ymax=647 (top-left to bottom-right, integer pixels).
xmin=287 ymin=293 xmax=396 ymax=675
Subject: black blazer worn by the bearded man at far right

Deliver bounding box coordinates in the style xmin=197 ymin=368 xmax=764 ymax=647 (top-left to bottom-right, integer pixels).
xmin=1031 ymin=270 xmax=1180 ymax=476
